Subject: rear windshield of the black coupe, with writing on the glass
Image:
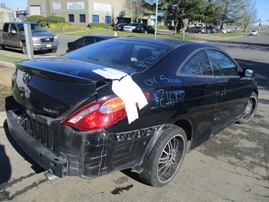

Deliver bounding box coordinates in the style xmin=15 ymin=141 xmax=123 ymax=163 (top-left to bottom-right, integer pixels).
xmin=64 ymin=40 xmax=171 ymax=71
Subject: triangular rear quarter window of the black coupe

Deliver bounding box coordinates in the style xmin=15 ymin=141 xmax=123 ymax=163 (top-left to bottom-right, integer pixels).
xmin=180 ymin=50 xmax=212 ymax=75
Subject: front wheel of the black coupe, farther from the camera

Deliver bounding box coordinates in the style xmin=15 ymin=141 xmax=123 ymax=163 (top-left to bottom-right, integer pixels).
xmin=237 ymin=92 xmax=258 ymax=124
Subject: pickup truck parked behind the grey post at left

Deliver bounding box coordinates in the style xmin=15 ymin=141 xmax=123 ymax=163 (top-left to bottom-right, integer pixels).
xmin=0 ymin=22 xmax=59 ymax=54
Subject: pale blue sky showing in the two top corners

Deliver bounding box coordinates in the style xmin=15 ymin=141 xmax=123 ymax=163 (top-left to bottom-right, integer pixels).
xmin=0 ymin=0 xmax=269 ymax=25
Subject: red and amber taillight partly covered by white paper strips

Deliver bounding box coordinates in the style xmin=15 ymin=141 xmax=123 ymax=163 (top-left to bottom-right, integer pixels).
xmin=62 ymin=92 xmax=149 ymax=131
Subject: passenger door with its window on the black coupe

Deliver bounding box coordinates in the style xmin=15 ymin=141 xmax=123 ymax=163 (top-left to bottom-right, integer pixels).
xmin=207 ymin=50 xmax=250 ymax=130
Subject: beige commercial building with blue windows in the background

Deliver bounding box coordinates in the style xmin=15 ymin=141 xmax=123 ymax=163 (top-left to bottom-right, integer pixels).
xmin=28 ymin=0 xmax=152 ymax=26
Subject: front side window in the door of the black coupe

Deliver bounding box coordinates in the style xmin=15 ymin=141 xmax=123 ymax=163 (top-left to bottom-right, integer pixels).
xmin=207 ymin=50 xmax=238 ymax=76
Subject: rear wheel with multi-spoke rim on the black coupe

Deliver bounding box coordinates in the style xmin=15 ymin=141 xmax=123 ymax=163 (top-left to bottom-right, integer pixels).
xmin=138 ymin=125 xmax=187 ymax=187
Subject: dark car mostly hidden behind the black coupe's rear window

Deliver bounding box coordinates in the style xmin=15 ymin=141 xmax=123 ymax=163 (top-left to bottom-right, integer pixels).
xmin=66 ymin=34 xmax=116 ymax=52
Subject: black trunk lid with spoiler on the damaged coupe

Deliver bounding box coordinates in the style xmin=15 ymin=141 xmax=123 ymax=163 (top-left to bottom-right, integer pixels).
xmin=12 ymin=57 xmax=132 ymax=118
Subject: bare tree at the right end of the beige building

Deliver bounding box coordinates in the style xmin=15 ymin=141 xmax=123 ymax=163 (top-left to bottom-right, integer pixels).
xmin=125 ymin=0 xmax=145 ymax=22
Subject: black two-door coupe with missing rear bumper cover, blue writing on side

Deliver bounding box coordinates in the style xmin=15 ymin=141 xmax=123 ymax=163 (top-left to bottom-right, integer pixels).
xmin=7 ymin=38 xmax=258 ymax=187
